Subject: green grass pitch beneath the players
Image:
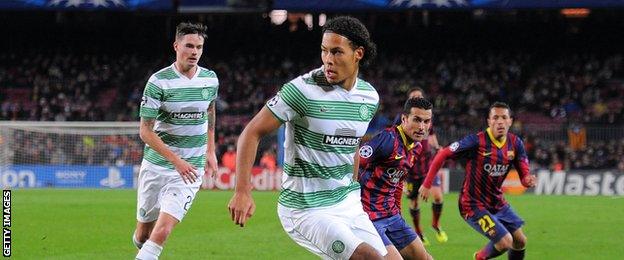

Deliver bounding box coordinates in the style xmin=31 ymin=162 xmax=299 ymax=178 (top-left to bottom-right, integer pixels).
xmin=11 ymin=189 xmax=624 ymax=260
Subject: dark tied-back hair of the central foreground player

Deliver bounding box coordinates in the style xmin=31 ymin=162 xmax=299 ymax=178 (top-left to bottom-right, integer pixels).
xmin=323 ymin=16 xmax=377 ymax=67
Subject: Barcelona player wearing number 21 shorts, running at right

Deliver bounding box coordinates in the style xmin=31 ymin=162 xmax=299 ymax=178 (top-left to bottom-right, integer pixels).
xmin=419 ymin=102 xmax=536 ymax=259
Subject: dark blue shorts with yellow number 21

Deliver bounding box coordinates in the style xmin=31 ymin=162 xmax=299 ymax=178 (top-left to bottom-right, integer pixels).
xmin=466 ymin=205 xmax=524 ymax=243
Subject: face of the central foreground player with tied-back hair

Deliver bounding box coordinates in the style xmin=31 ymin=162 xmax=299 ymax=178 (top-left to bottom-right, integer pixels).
xmin=321 ymin=32 xmax=364 ymax=87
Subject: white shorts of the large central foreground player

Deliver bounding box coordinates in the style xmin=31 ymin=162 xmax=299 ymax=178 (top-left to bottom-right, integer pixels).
xmin=277 ymin=190 xmax=388 ymax=259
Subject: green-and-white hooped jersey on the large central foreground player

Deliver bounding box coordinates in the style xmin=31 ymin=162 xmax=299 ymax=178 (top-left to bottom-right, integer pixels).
xmin=266 ymin=67 xmax=379 ymax=209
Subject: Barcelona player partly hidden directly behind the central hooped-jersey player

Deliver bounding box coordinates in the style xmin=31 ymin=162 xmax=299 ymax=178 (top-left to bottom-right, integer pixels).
xmin=358 ymin=98 xmax=432 ymax=259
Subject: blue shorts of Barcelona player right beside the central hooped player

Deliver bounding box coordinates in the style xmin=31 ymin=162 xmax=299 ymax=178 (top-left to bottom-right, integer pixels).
xmin=373 ymin=214 xmax=418 ymax=251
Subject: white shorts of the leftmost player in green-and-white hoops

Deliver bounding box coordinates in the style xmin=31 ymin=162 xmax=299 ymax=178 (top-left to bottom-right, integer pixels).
xmin=137 ymin=166 xmax=204 ymax=223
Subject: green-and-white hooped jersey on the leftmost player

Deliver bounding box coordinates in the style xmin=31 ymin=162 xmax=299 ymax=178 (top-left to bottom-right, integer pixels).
xmin=140 ymin=64 xmax=219 ymax=174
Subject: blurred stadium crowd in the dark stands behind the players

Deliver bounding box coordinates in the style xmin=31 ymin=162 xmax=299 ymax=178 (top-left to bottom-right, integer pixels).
xmin=0 ymin=12 xmax=624 ymax=170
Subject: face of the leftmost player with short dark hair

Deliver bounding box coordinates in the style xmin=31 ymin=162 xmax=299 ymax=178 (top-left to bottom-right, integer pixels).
xmin=173 ymin=34 xmax=204 ymax=70
